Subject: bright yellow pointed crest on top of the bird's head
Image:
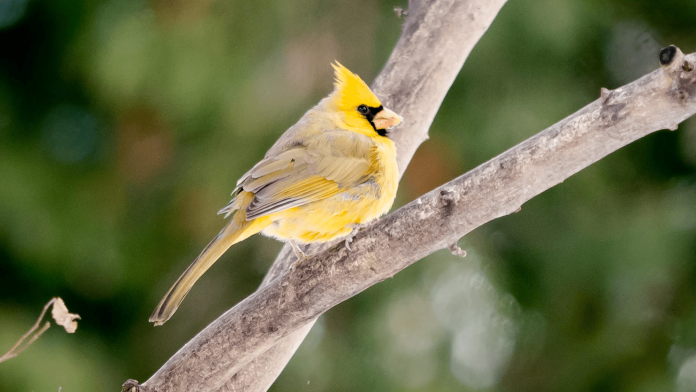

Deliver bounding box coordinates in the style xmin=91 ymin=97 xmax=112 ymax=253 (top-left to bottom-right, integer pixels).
xmin=331 ymin=61 xmax=382 ymax=111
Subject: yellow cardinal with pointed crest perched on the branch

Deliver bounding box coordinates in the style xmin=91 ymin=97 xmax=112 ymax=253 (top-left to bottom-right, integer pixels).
xmin=150 ymin=62 xmax=401 ymax=325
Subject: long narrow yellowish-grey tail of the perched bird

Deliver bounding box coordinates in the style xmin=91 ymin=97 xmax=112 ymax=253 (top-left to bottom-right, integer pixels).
xmin=150 ymin=192 xmax=270 ymax=326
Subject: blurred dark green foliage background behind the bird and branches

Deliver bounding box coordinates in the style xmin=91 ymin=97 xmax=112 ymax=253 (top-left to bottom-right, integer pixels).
xmin=0 ymin=0 xmax=696 ymax=392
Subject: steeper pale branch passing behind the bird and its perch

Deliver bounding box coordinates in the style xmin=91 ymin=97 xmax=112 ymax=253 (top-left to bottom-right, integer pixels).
xmin=123 ymin=0 xmax=507 ymax=392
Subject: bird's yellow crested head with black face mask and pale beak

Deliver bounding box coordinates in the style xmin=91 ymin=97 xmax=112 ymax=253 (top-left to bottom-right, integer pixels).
xmin=330 ymin=61 xmax=402 ymax=136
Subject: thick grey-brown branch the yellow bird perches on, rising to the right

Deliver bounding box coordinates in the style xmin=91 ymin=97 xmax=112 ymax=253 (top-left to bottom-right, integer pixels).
xmin=129 ymin=40 xmax=696 ymax=391
